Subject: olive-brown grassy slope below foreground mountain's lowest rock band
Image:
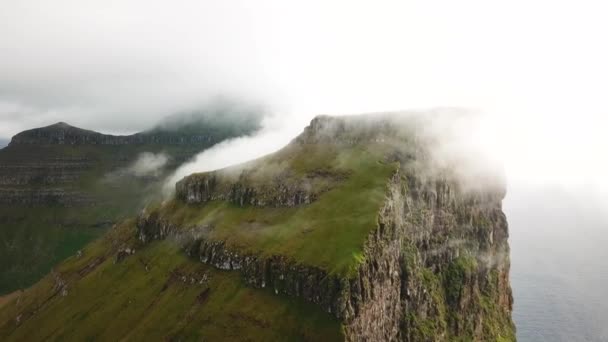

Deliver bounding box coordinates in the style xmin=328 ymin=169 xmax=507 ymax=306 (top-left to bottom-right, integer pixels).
xmin=0 ymin=224 xmax=343 ymax=341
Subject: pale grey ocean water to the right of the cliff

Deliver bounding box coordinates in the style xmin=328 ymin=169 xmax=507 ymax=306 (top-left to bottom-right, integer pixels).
xmin=504 ymin=186 xmax=608 ymax=342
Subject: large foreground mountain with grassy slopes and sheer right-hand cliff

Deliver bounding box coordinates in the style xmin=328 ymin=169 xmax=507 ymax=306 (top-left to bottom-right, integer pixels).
xmin=0 ymin=113 xmax=515 ymax=341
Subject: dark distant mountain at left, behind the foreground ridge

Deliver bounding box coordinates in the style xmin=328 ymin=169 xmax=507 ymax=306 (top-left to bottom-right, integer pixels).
xmin=0 ymin=113 xmax=260 ymax=294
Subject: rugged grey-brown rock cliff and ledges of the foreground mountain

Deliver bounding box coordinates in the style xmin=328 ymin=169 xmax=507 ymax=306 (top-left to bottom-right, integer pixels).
xmin=137 ymin=113 xmax=515 ymax=341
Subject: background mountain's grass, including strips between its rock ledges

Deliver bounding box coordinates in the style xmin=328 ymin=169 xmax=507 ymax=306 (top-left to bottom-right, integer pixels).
xmin=0 ymin=145 xmax=211 ymax=295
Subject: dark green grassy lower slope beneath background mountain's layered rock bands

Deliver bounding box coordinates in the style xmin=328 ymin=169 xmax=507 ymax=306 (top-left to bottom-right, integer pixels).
xmin=0 ymin=166 xmax=158 ymax=294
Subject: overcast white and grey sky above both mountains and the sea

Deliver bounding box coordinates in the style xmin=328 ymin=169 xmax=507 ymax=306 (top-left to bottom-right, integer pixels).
xmin=0 ymin=0 xmax=608 ymax=192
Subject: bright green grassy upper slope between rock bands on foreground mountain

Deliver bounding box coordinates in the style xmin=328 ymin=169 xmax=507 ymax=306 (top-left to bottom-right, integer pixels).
xmin=160 ymin=144 xmax=397 ymax=276
